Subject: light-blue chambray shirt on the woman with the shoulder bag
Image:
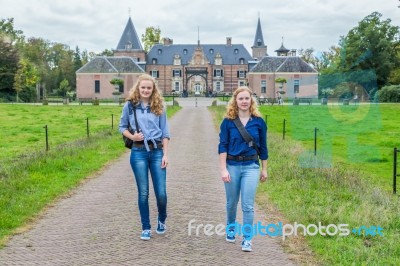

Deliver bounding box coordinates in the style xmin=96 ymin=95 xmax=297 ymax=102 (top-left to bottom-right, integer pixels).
xmin=119 ymin=102 xmax=170 ymax=151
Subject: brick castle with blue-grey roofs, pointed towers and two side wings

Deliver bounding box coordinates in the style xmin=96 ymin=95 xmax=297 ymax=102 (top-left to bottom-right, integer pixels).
xmin=76 ymin=17 xmax=318 ymax=99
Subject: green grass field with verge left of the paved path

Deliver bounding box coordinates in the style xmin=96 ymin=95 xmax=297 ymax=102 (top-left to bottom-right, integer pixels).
xmin=0 ymin=104 xmax=180 ymax=246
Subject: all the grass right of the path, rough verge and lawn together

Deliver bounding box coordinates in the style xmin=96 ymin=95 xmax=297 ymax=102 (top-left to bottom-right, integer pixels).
xmin=210 ymin=104 xmax=400 ymax=265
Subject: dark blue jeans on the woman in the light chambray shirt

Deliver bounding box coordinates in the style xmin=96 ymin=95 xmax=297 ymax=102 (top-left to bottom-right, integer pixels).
xmin=130 ymin=147 xmax=167 ymax=230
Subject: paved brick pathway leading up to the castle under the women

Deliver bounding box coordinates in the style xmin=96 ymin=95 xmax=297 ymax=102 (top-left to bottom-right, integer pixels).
xmin=0 ymin=98 xmax=293 ymax=266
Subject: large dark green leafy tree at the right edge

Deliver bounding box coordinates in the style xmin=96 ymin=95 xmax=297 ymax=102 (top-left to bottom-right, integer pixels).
xmin=338 ymin=12 xmax=400 ymax=89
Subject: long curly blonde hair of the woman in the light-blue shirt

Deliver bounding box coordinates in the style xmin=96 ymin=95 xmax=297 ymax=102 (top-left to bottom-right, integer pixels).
xmin=126 ymin=74 xmax=164 ymax=116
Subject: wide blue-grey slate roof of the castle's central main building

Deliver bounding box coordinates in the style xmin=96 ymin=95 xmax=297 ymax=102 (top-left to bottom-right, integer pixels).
xmin=146 ymin=44 xmax=253 ymax=65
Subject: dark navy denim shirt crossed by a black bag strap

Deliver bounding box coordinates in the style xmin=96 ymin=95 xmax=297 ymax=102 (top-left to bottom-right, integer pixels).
xmin=218 ymin=116 xmax=268 ymax=165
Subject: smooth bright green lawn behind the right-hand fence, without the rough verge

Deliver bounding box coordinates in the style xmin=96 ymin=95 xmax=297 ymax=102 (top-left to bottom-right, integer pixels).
xmin=260 ymin=104 xmax=400 ymax=191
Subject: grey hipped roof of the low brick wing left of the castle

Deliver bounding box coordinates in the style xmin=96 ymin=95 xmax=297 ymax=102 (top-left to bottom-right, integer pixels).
xmin=76 ymin=56 xmax=144 ymax=74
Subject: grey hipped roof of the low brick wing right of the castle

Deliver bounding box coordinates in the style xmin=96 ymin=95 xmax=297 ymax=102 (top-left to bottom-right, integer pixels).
xmin=250 ymin=56 xmax=318 ymax=73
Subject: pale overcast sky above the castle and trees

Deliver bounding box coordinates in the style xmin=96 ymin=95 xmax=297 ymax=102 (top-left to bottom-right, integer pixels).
xmin=0 ymin=0 xmax=400 ymax=55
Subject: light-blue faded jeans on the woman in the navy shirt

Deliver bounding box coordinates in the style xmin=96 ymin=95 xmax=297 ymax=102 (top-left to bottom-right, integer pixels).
xmin=225 ymin=163 xmax=260 ymax=238
